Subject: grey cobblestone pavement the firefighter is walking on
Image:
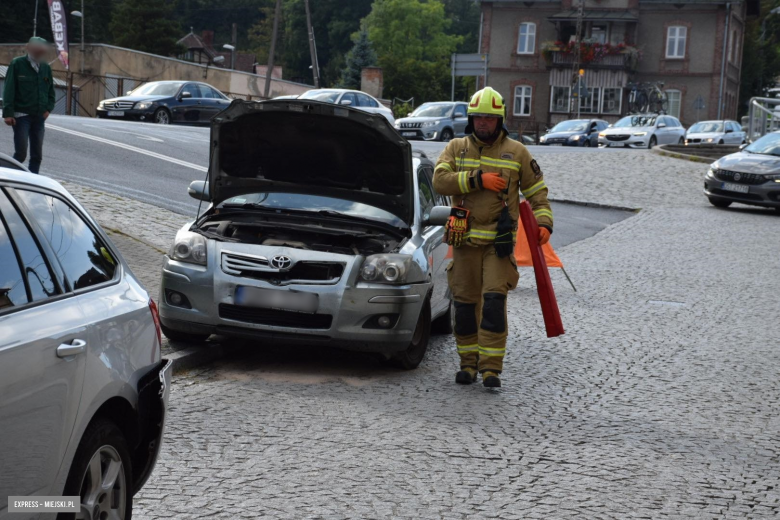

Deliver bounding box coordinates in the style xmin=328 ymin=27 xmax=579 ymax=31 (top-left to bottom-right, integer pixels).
xmin=62 ymin=151 xmax=780 ymax=519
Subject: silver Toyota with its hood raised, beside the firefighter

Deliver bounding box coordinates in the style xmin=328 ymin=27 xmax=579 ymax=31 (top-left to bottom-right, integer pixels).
xmin=160 ymin=99 xmax=450 ymax=369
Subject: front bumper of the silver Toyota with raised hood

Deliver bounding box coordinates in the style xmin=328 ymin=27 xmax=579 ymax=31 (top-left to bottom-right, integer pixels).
xmin=159 ymin=257 xmax=431 ymax=353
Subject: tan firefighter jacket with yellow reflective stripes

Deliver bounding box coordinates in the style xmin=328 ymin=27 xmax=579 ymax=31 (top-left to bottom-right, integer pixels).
xmin=433 ymin=130 xmax=553 ymax=245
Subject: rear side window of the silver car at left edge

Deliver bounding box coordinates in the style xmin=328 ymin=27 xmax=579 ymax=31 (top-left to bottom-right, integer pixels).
xmin=17 ymin=190 xmax=116 ymax=290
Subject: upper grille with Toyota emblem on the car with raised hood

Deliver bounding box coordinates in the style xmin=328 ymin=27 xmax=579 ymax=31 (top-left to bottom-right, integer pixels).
xmin=222 ymin=253 xmax=344 ymax=285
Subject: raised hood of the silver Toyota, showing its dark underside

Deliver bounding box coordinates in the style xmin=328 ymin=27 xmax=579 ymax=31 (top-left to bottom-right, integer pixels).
xmin=209 ymin=99 xmax=414 ymax=226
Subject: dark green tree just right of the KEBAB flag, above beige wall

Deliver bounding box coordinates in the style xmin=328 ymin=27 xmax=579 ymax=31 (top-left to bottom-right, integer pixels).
xmin=110 ymin=0 xmax=183 ymax=56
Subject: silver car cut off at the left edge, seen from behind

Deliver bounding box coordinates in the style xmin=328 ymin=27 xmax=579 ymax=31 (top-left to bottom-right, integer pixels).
xmin=0 ymin=168 xmax=171 ymax=520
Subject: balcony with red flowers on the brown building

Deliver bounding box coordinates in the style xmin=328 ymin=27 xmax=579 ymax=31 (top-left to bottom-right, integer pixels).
xmin=542 ymin=42 xmax=641 ymax=72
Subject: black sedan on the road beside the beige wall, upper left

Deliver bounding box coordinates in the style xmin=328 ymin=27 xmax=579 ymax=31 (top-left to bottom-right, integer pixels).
xmin=97 ymin=81 xmax=231 ymax=125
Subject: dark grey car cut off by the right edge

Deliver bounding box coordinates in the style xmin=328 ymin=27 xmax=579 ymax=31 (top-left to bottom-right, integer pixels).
xmin=704 ymin=132 xmax=780 ymax=212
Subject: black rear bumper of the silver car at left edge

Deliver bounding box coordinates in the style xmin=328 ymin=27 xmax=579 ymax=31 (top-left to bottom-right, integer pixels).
xmin=133 ymin=359 xmax=173 ymax=494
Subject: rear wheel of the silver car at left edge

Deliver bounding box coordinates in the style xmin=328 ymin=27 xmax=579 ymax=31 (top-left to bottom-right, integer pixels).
xmin=57 ymin=419 xmax=133 ymax=520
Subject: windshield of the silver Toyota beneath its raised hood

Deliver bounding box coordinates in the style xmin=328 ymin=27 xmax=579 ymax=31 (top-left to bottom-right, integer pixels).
xmin=218 ymin=193 xmax=406 ymax=228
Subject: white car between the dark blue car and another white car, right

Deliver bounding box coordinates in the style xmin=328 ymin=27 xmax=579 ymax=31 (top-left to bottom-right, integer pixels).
xmin=599 ymin=114 xmax=685 ymax=148
